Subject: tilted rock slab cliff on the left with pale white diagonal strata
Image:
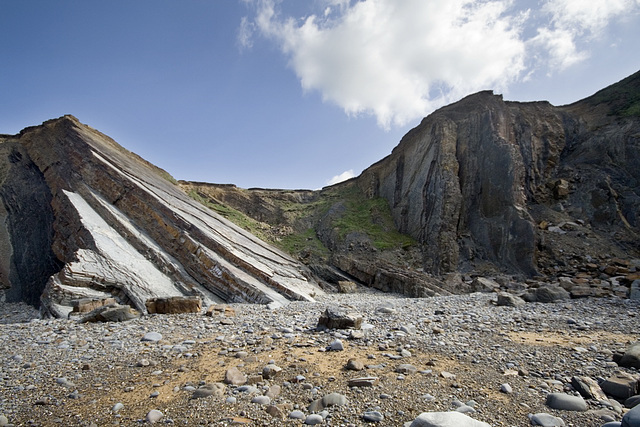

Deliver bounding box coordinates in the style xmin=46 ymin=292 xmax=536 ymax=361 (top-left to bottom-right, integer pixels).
xmin=0 ymin=116 xmax=321 ymax=316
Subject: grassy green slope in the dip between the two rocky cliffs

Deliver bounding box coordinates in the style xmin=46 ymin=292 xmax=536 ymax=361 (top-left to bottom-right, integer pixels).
xmin=187 ymin=183 xmax=415 ymax=258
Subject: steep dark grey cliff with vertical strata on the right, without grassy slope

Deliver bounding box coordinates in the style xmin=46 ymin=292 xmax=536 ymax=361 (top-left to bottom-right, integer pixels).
xmin=357 ymin=73 xmax=640 ymax=276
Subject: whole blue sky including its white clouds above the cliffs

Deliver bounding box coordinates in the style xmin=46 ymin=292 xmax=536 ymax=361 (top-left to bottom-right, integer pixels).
xmin=0 ymin=0 xmax=640 ymax=189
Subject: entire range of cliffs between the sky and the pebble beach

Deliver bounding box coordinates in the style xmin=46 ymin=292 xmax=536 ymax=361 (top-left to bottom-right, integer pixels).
xmin=0 ymin=72 xmax=640 ymax=310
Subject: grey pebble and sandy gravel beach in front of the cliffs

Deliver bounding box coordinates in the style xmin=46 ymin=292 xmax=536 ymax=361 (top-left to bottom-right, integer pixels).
xmin=0 ymin=293 xmax=640 ymax=426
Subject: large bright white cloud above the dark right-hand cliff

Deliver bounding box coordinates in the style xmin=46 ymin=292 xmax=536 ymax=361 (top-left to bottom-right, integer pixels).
xmin=241 ymin=0 xmax=640 ymax=128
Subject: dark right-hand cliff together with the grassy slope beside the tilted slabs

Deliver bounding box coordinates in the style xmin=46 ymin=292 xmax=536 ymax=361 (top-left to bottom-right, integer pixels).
xmin=189 ymin=73 xmax=640 ymax=284
